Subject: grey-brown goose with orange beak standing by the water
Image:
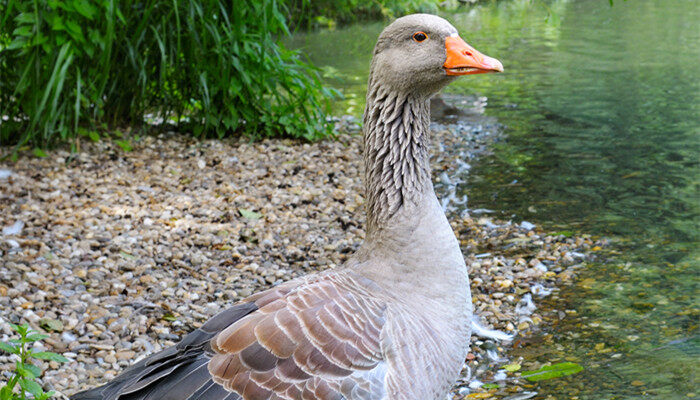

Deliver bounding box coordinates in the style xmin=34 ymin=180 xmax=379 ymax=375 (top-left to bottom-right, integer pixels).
xmin=73 ymin=14 xmax=503 ymax=400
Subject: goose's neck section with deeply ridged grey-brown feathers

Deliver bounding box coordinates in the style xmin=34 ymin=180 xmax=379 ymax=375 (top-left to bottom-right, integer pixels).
xmin=363 ymin=81 xmax=432 ymax=234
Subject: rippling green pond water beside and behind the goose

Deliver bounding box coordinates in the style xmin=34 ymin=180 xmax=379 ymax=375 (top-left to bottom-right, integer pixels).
xmin=295 ymin=0 xmax=700 ymax=399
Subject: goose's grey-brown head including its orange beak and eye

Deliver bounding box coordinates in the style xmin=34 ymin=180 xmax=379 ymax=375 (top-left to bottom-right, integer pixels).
xmin=370 ymin=14 xmax=503 ymax=97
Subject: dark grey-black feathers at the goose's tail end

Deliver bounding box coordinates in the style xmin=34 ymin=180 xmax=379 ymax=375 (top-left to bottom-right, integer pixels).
xmin=71 ymin=303 xmax=257 ymax=400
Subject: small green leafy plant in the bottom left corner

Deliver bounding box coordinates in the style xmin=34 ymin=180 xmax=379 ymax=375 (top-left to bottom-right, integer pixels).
xmin=0 ymin=325 xmax=68 ymax=400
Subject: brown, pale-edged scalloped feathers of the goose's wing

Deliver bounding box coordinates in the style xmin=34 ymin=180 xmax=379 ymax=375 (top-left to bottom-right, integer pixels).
xmin=209 ymin=271 xmax=386 ymax=400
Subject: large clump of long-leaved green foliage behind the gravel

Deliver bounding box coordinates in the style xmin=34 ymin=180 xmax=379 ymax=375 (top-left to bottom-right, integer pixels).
xmin=0 ymin=0 xmax=335 ymax=152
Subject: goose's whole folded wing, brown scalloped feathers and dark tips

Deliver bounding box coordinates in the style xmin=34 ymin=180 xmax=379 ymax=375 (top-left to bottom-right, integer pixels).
xmin=73 ymin=270 xmax=386 ymax=400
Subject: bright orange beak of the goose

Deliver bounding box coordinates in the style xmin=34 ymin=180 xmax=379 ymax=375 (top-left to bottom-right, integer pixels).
xmin=443 ymin=36 xmax=503 ymax=75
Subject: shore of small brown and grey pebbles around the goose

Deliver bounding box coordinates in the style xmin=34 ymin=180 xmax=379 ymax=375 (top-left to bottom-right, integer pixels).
xmin=0 ymin=102 xmax=596 ymax=398
